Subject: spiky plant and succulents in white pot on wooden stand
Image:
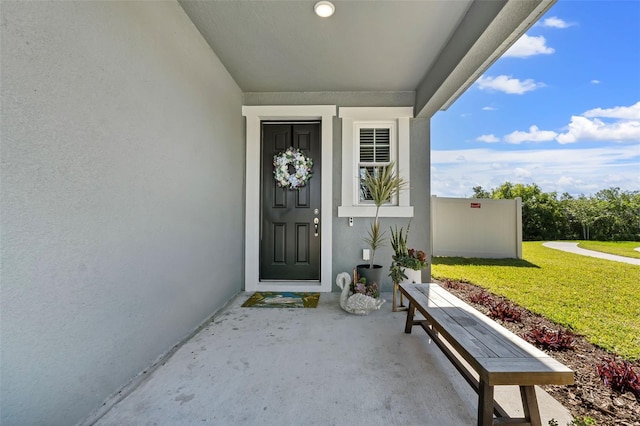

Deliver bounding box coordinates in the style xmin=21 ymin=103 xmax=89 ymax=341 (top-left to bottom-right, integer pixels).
xmin=389 ymin=220 xmax=429 ymax=311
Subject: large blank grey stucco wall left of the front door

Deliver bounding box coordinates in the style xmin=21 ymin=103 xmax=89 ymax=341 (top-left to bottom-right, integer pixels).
xmin=0 ymin=0 xmax=244 ymax=426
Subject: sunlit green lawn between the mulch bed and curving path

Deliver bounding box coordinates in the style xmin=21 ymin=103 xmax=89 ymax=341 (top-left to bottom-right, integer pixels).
xmin=432 ymin=242 xmax=640 ymax=360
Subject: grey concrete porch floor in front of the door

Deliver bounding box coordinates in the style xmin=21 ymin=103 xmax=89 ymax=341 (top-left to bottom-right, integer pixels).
xmin=86 ymin=293 xmax=571 ymax=426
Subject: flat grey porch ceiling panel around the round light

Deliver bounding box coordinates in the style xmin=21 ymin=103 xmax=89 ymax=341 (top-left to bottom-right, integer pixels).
xmin=181 ymin=0 xmax=472 ymax=92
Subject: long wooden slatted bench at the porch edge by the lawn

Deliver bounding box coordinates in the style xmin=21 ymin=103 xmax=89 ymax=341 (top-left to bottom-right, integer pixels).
xmin=400 ymin=284 xmax=574 ymax=426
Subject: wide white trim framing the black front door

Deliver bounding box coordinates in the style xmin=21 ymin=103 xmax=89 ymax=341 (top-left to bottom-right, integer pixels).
xmin=242 ymin=105 xmax=337 ymax=292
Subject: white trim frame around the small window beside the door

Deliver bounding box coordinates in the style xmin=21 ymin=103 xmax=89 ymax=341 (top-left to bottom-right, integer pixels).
xmin=338 ymin=107 xmax=413 ymax=217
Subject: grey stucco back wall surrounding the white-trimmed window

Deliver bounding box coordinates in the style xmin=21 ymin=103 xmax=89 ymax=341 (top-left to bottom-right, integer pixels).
xmin=244 ymin=92 xmax=431 ymax=291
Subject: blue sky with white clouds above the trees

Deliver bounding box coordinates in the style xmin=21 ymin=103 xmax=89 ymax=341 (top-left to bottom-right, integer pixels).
xmin=431 ymin=0 xmax=640 ymax=197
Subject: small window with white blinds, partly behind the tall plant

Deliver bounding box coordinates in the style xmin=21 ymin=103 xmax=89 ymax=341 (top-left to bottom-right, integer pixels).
xmin=358 ymin=127 xmax=391 ymax=203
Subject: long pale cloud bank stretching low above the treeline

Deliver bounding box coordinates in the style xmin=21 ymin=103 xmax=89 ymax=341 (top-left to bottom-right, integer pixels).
xmin=431 ymin=144 xmax=640 ymax=197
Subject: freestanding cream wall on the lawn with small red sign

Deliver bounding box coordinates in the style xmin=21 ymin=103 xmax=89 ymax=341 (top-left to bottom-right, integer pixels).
xmin=431 ymin=196 xmax=522 ymax=259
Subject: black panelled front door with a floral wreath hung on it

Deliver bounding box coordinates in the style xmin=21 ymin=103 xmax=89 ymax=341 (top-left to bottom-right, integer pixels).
xmin=260 ymin=122 xmax=322 ymax=281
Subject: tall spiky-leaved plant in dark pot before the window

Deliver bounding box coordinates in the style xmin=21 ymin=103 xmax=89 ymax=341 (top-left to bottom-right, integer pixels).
xmin=357 ymin=161 xmax=407 ymax=286
